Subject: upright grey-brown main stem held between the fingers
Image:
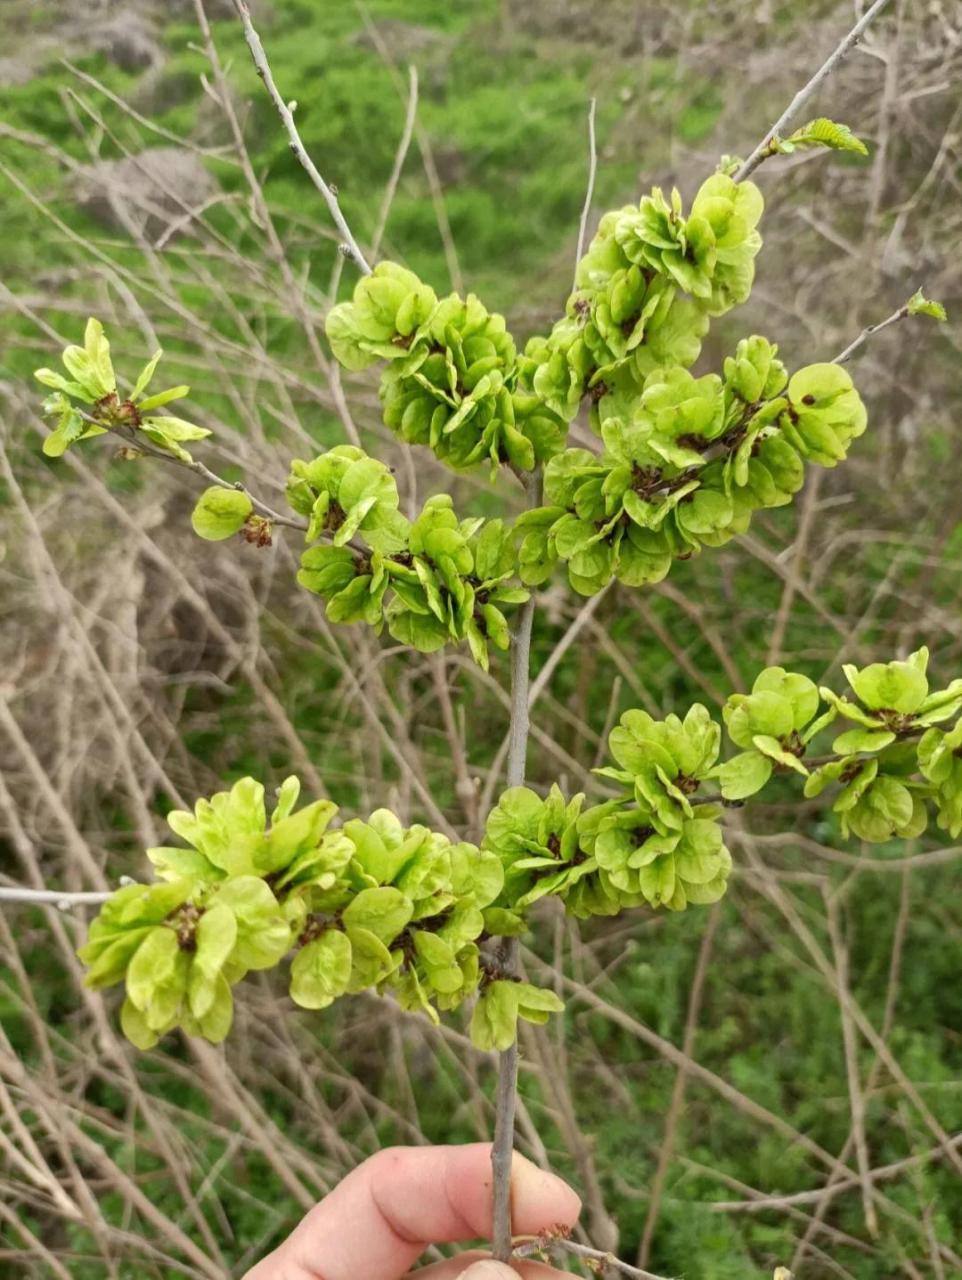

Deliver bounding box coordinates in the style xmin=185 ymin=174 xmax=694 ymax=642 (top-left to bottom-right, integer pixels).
xmin=491 ymin=477 xmax=541 ymax=1262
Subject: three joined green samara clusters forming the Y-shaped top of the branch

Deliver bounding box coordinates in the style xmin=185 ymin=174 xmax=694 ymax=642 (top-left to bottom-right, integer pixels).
xmin=321 ymin=173 xmax=866 ymax=595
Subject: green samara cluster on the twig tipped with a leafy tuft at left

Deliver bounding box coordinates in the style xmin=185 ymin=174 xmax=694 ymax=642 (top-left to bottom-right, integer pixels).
xmin=292 ymin=483 xmax=528 ymax=669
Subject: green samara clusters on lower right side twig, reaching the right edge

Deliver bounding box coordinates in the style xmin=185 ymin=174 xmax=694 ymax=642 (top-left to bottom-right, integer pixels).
xmin=570 ymin=649 xmax=962 ymax=890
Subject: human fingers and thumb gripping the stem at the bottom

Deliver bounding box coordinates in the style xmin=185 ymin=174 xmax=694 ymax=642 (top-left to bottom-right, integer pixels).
xmin=244 ymin=1143 xmax=581 ymax=1280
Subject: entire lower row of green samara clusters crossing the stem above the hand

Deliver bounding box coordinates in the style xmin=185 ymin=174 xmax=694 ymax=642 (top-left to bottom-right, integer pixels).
xmin=81 ymin=649 xmax=962 ymax=1050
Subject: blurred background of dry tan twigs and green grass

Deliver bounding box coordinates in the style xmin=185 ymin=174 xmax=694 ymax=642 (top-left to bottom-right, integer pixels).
xmin=0 ymin=0 xmax=962 ymax=1280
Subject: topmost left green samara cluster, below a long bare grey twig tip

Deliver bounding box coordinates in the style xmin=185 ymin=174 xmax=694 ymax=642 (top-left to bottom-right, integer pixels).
xmin=326 ymin=262 xmax=564 ymax=472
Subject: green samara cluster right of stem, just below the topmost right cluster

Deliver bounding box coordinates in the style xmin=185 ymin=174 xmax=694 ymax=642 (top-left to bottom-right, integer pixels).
xmin=516 ymin=345 xmax=865 ymax=595
